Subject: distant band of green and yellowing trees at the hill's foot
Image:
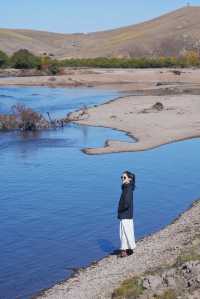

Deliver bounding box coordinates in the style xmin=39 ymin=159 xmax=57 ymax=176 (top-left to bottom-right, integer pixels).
xmin=0 ymin=49 xmax=200 ymax=71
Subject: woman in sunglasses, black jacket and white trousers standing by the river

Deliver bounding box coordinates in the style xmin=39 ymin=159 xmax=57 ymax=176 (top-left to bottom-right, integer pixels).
xmin=118 ymin=171 xmax=136 ymax=257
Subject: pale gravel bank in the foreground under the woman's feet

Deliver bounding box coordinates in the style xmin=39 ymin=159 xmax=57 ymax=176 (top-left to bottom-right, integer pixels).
xmin=34 ymin=201 xmax=200 ymax=299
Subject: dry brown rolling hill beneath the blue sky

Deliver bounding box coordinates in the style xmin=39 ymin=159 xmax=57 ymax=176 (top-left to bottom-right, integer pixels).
xmin=0 ymin=6 xmax=200 ymax=59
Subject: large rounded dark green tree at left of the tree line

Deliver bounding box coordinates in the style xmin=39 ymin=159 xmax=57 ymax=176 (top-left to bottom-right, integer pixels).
xmin=11 ymin=49 xmax=40 ymax=69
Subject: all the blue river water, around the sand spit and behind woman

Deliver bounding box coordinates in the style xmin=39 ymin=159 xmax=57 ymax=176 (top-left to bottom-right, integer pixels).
xmin=0 ymin=87 xmax=200 ymax=299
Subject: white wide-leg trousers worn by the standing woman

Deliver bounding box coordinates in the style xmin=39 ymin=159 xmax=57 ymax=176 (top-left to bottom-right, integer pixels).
xmin=119 ymin=219 xmax=136 ymax=250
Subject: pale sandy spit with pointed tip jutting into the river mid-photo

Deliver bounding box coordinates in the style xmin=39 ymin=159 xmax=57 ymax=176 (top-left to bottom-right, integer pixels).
xmin=70 ymin=94 xmax=200 ymax=154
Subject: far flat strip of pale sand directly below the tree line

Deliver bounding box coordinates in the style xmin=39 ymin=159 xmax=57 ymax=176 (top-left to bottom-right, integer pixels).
xmin=0 ymin=68 xmax=200 ymax=91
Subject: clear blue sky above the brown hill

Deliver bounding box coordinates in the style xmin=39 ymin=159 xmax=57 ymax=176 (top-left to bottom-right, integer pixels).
xmin=0 ymin=0 xmax=200 ymax=33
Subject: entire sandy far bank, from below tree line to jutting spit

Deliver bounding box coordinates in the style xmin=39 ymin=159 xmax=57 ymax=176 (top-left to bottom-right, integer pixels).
xmin=0 ymin=68 xmax=200 ymax=154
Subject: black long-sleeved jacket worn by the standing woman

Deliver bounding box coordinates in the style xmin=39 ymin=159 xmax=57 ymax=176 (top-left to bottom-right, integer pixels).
xmin=118 ymin=182 xmax=135 ymax=219
